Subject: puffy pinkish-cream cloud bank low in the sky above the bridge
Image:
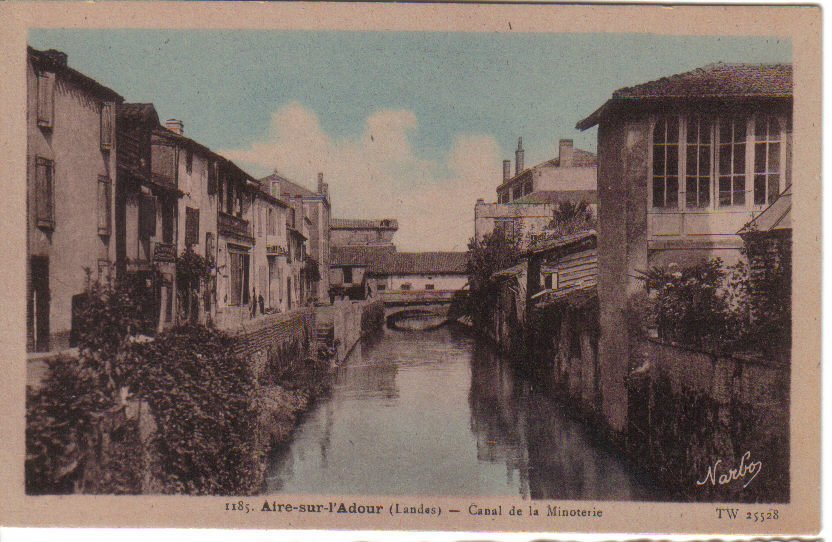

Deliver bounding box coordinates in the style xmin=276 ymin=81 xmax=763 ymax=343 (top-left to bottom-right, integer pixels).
xmin=222 ymin=102 xmax=501 ymax=250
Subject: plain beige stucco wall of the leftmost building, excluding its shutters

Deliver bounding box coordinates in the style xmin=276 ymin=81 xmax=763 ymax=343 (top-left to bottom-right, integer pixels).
xmin=26 ymin=58 xmax=116 ymax=349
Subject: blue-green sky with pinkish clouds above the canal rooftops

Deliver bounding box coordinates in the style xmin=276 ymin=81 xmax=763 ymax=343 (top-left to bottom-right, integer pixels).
xmin=29 ymin=29 xmax=791 ymax=250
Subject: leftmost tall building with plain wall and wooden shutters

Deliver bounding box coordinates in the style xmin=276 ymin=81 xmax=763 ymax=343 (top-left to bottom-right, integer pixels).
xmin=26 ymin=47 xmax=123 ymax=351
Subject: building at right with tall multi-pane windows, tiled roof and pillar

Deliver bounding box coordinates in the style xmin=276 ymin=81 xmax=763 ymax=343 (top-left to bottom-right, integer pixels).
xmin=577 ymin=63 xmax=792 ymax=430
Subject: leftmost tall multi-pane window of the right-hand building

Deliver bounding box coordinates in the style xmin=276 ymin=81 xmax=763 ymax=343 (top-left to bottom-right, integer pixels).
xmin=653 ymin=117 xmax=679 ymax=208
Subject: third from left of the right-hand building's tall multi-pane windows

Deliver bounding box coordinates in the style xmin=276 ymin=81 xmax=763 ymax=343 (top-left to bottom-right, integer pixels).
xmin=718 ymin=116 xmax=746 ymax=207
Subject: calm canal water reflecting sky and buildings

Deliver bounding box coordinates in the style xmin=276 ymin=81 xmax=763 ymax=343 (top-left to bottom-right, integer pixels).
xmin=265 ymin=327 xmax=657 ymax=500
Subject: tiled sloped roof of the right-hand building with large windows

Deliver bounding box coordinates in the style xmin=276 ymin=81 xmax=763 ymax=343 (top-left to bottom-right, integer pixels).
xmin=576 ymin=62 xmax=794 ymax=130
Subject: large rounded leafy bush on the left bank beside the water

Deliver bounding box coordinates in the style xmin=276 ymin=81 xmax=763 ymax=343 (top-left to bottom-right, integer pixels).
xmin=133 ymin=326 xmax=261 ymax=495
